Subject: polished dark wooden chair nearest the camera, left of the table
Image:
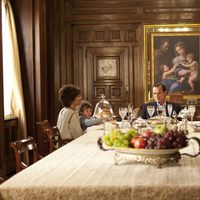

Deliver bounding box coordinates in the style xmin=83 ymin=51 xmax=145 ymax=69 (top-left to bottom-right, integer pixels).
xmin=10 ymin=137 xmax=42 ymax=173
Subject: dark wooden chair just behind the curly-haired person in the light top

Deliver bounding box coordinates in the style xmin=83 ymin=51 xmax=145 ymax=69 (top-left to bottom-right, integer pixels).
xmin=37 ymin=120 xmax=63 ymax=153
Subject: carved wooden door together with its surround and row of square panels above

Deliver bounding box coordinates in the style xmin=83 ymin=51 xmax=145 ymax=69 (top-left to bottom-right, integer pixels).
xmin=73 ymin=24 xmax=139 ymax=115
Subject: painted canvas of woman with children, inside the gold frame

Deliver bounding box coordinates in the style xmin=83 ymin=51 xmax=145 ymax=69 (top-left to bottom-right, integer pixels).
xmin=152 ymin=36 xmax=200 ymax=95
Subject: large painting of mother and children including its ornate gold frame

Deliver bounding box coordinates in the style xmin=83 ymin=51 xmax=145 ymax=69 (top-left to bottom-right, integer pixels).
xmin=144 ymin=24 xmax=200 ymax=101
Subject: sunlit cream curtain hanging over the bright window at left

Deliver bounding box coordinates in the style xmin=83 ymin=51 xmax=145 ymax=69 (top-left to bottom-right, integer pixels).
xmin=2 ymin=0 xmax=27 ymax=137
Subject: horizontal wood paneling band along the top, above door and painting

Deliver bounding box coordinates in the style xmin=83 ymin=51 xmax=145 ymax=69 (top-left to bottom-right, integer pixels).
xmin=72 ymin=0 xmax=200 ymax=24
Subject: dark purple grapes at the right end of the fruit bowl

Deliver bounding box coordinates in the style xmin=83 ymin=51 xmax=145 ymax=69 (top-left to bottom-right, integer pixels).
xmin=146 ymin=130 xmax=187 ymax=149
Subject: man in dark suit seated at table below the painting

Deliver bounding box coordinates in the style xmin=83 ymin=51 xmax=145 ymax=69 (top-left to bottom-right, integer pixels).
xmin=141 ymin=83 xmax=182 ymax=119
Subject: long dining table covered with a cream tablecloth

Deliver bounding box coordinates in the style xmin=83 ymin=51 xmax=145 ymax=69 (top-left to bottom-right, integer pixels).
xmin=0 ymin=122 xmax=200 ymax=200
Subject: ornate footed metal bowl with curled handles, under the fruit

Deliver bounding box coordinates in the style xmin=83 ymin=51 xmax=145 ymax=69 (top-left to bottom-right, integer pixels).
xmin=97 ymin=137 xmax=200 ymax=168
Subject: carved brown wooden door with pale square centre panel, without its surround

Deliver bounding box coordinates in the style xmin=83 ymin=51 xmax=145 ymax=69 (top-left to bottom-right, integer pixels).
xmin=85 ymin=46 xmax=133 ymax=116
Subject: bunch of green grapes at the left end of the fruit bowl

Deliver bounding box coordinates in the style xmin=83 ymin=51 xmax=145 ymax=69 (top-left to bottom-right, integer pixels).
xmin=103 ymin=129 xmax=138 ymax=147
